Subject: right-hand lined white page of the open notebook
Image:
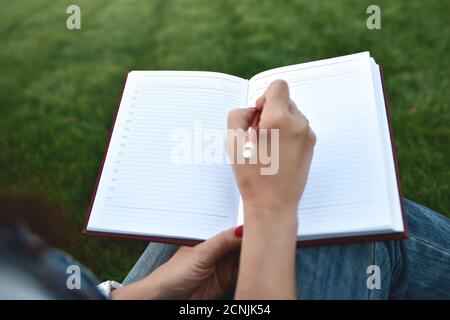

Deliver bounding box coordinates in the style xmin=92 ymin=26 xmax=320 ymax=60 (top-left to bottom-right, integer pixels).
xmin=249 ymin=52 xmax=391 ymax=239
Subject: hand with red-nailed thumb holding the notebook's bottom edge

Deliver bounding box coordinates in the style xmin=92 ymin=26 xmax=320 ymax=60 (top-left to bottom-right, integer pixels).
xmin=112 ymin=228 xmax=242 ymax=299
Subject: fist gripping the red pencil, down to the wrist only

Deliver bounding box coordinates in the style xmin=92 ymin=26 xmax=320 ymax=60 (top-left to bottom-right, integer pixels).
xmin=228 ymin=80 xmax=316 ymax=219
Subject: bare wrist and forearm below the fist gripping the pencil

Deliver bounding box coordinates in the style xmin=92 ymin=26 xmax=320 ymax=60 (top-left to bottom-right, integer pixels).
xmin=235 ymin=203 xmax=298 ymax=299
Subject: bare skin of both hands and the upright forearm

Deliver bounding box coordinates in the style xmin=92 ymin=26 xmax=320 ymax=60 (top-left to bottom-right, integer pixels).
xmin=111 ymin=80 xmax=316 ymax=299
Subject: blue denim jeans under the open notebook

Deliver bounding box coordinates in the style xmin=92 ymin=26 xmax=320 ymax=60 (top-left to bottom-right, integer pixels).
xmin=123 ymin=200 xmax=450 ymax=299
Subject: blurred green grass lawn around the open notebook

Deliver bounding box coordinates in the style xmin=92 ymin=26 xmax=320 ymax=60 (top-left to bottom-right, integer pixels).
xmin=0 ymin=0 xmax=450 ymax=280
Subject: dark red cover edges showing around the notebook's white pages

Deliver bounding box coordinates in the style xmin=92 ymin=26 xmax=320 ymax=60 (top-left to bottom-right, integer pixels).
xmin=83 ymin=65 xmax=408 ymax=248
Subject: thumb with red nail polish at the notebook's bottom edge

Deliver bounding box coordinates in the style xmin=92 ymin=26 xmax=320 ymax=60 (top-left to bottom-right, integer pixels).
xmin=197 ymin=227 xmax=242 ymax=264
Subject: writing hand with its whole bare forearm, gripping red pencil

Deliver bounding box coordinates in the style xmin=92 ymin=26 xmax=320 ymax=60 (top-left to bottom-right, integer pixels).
xmin=228 ymin=80 xmax=316 ymax=299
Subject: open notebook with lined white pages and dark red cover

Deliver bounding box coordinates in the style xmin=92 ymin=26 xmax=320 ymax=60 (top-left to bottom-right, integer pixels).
xmin=84 ymin=52 xmax=407 ymax=246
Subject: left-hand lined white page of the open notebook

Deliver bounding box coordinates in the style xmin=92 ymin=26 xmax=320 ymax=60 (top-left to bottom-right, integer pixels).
xmin=88 ymin=71 xmax=248 ymax=239
